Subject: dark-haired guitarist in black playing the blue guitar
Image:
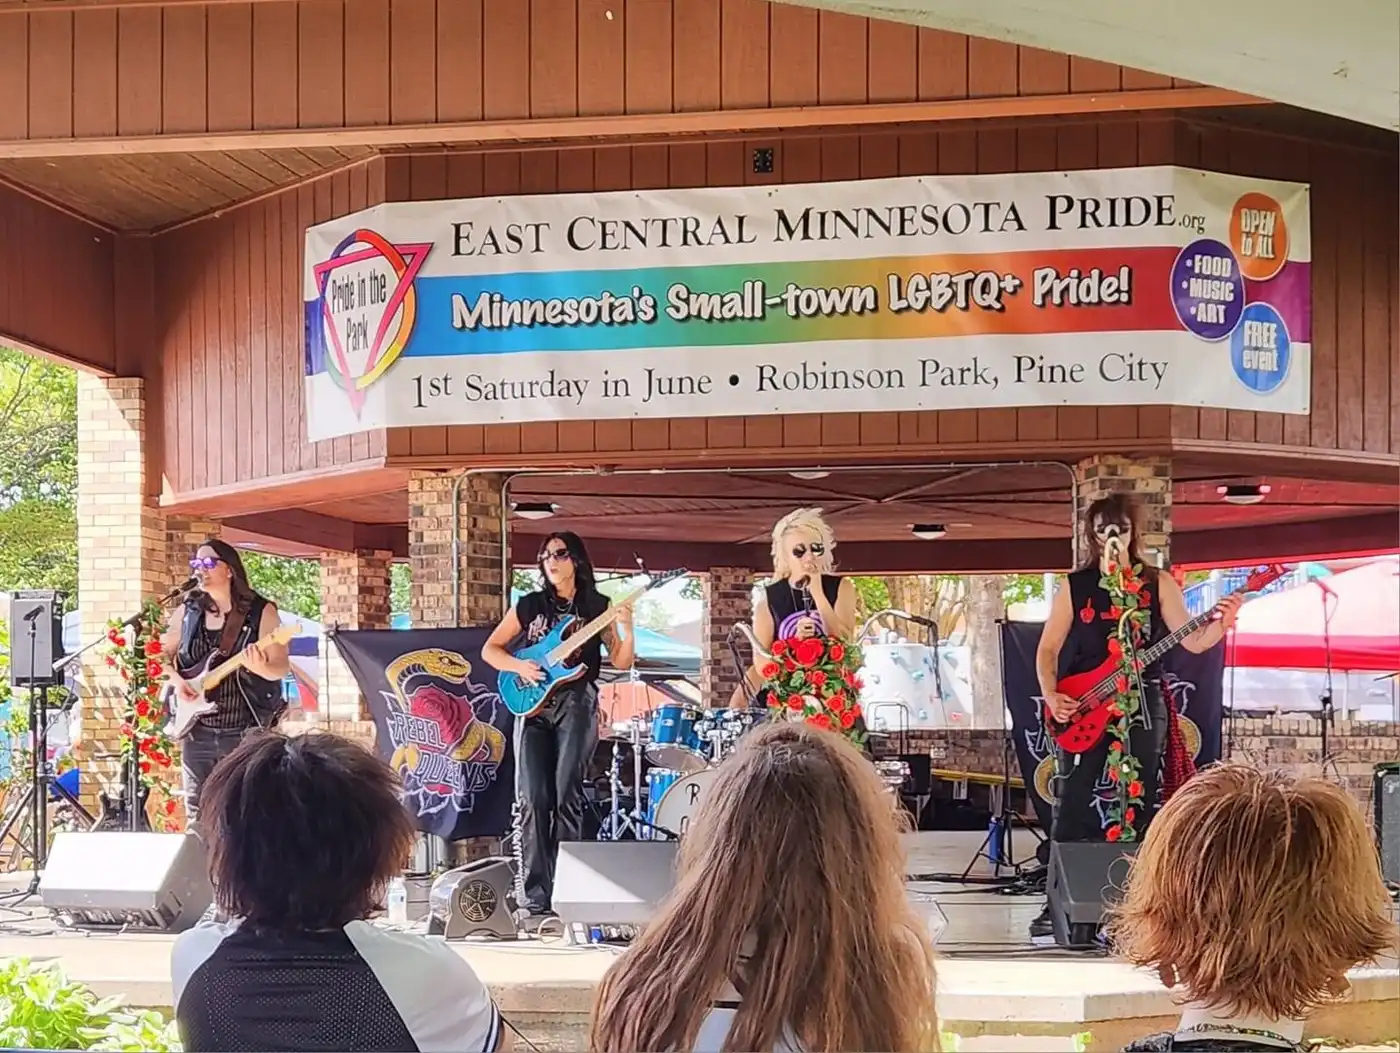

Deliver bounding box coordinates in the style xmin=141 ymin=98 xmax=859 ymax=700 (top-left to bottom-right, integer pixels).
xmin=482 ymin=531 xmax=634 ymax=931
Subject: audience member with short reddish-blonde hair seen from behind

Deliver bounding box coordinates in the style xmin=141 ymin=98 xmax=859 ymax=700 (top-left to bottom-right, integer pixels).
xmin=1107 ymin=765 xmax=1396 ymax=1053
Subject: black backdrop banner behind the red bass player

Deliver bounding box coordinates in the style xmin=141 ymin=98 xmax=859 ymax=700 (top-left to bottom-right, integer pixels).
xmin=1001 ymin=622 xmax=1225 ymax=830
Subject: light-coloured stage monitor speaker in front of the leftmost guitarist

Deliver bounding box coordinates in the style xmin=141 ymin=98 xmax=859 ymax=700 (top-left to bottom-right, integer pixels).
xmin=39 ymin=832 xmax=214 ymax=933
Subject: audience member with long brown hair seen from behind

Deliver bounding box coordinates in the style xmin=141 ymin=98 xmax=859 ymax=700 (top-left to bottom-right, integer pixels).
xmin=591 ymin=724 xmax=938 ymax=1053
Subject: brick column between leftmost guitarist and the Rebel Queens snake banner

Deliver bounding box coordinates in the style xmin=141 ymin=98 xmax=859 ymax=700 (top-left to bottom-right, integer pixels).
xmin=318 ymin=550 xmax=393 ymax=738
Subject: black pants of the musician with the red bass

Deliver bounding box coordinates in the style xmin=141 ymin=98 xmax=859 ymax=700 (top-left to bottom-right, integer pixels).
xmin=1050 ymin=678 xmax=1166 ymax=842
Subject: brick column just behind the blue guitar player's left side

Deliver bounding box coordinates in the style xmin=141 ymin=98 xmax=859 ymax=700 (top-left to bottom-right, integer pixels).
xmin=409 ymin=472 xmax=507 ymax=627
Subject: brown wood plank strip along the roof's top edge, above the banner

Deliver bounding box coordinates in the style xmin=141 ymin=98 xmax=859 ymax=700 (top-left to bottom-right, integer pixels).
xmin=0 ymin=0 xmax=1187 ymax=140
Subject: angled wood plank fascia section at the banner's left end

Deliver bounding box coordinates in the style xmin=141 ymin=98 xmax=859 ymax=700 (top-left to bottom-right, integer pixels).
xmin=155 ymin=160 xmax=384 ymax=494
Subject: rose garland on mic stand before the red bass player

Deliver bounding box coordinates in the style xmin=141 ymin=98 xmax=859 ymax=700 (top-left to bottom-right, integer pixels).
xmin=1099 ymin=559 xmax=1152 ymax=842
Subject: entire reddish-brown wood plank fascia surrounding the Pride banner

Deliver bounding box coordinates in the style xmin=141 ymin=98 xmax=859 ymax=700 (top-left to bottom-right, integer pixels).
xmin=147 ymin=119 xmax=1400 ymax=493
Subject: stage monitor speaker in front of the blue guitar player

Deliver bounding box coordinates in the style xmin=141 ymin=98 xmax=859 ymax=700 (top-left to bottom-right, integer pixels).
xmin=554 ymin=842 xmax=679 ymax=927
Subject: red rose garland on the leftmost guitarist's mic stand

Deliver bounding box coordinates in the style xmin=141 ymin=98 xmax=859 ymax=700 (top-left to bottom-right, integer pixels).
xmin=104 ymin=599 xmax=182 ymax=830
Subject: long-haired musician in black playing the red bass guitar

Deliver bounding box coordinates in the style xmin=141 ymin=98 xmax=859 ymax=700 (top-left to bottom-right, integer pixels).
xmin=1030 ymin=494 xmax=1242 ymax=937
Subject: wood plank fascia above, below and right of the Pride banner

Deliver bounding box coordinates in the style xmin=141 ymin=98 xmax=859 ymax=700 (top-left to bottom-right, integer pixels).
xmin=386 ymin=119 xmax=1400 ymax=459
